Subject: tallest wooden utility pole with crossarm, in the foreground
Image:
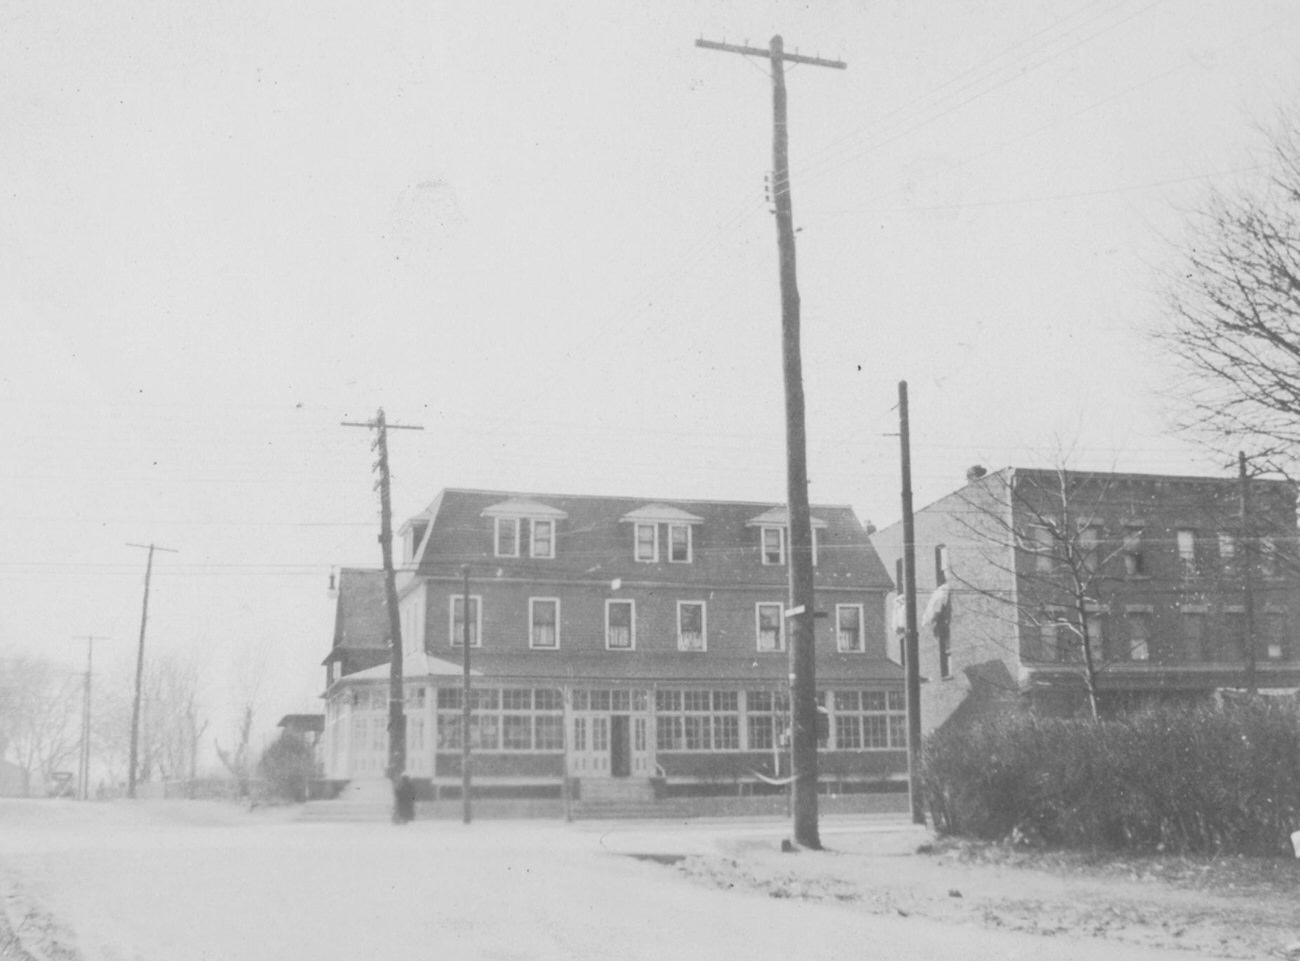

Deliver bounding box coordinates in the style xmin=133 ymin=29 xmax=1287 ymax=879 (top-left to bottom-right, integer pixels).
xmin=696 ymin=35 xmax=848 ymax=848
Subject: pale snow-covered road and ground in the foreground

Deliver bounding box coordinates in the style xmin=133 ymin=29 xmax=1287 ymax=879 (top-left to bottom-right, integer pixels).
xmin=0 ymin=801 xmax=1284 ymax=961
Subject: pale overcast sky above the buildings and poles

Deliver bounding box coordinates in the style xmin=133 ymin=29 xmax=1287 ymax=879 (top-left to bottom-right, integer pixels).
xmin=0 ymin=0 xmax=1300 ymax=754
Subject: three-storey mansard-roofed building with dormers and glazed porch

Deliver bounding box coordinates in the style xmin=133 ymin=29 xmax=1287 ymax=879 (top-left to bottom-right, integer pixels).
xmin=325 ymin=489 xmax=906 ymax=793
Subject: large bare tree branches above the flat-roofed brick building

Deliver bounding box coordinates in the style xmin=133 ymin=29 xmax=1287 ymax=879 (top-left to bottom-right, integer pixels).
xmin=1156 ymin=108 xmax=1300 ymax=473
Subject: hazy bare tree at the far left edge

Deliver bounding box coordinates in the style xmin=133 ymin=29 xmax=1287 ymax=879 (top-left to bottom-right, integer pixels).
xmin=0 ymin=654 xmax=82 ymax=792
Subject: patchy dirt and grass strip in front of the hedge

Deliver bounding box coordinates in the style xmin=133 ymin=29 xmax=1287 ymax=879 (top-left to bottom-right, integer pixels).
xmin=675 ymin=836 xmax=1300 ymax=958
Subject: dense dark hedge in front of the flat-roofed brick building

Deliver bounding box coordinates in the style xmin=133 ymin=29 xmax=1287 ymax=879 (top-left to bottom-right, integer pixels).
xmin=922 ymin=702 xmax=1300 ymax=854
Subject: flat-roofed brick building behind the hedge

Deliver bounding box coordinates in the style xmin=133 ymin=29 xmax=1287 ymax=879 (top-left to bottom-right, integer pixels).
xmin=871 ymin=468 xmax=1300 ymax=731
